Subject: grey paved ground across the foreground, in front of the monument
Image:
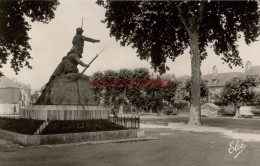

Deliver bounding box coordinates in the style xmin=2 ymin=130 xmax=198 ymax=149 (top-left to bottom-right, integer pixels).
xmin=0 ymin=122 xmax=260 ymax=166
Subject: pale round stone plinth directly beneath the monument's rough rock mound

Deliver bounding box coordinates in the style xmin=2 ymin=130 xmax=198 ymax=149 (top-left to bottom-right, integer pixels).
xmin=20 ymin=105 xmax=110 ymax=120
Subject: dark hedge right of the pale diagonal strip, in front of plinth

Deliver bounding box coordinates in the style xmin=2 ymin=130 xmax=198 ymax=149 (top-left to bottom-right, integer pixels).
xmin=41 ymin=119 xmax=127 ymax=135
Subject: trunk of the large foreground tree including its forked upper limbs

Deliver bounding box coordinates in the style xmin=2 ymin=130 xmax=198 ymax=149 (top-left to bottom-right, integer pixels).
xmin=177 ymin=1 xmax=205 ymax=125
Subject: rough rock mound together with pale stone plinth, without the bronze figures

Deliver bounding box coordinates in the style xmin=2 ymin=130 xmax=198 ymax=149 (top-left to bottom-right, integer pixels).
xmin=20 ymin=73 xmax=110 ymax=120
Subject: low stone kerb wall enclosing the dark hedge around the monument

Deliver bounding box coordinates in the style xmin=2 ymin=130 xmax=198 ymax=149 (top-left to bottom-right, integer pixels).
xmin=0 ymin=129 xmax=144 ymax=146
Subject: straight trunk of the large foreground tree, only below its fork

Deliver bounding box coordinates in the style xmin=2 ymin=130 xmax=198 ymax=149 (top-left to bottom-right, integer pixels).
xmin=188 ymin=32 xmax=202 ymax=125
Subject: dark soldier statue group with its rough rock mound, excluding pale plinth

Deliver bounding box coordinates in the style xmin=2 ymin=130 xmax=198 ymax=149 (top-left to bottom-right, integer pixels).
xmin=36 ymin=28 xmax=100 ymax=105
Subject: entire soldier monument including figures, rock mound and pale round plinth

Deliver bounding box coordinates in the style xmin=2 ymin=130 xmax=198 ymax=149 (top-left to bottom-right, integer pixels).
xmin=20 ymin=28 xmax=109 ymax=120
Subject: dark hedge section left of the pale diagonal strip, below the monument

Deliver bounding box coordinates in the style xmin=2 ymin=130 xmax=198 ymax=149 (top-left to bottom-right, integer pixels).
xmin=0 ymin=117 xmax=43 ymax=135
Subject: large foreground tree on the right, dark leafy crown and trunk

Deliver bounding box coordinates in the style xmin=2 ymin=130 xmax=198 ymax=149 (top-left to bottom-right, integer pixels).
xmin=97 ymin=0 xmax=259 ymax=125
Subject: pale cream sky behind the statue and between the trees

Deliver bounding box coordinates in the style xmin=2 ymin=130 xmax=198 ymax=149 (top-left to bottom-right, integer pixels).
xmin=1 ymin=0 xmax=260 ymax=90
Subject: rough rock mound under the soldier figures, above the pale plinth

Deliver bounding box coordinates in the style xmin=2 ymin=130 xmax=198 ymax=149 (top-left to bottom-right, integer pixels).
xmin=36 ymin=73 xmax=97 ymax=105
